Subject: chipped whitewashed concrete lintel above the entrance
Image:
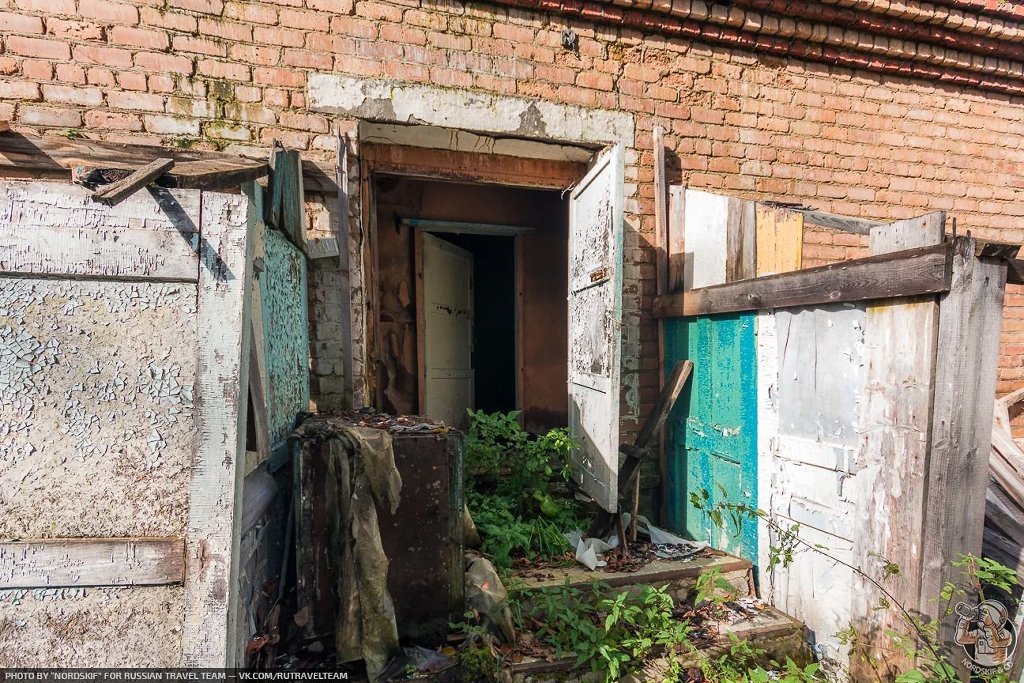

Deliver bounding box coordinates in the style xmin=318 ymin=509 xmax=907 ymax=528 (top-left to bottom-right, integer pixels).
xmin=306 ymin=74 xmax=636 ymax=147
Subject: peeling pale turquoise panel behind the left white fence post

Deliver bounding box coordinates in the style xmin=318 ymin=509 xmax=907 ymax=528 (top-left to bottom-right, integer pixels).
xmin=259 ymin=229 xmax=309 ymax=461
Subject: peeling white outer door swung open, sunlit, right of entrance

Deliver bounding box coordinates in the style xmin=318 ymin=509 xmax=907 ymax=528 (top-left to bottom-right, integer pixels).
xmin=568 ymin=146 xmax=623 ymax=511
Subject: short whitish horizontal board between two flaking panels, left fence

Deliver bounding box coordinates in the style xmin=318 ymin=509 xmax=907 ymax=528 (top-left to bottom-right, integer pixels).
xmin=0 ymin=539 xmax=185 ymax=590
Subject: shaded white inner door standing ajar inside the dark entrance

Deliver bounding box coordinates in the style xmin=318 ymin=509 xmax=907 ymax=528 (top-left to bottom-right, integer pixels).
xmin=421 ymin=232 xmax=474 ymax=427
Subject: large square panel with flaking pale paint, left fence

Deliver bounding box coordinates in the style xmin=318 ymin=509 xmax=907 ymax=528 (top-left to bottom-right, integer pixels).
xmin=0 ymin=278 xmax=198 ymax=540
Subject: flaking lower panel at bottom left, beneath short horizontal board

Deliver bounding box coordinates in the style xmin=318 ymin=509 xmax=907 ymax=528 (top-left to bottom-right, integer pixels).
xmin=0 ymin=586 xmax=183 ymax=668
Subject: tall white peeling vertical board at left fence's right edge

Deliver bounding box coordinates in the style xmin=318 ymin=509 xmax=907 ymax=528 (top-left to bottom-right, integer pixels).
xmin=181 ymin=183 xmax=254 ymax=667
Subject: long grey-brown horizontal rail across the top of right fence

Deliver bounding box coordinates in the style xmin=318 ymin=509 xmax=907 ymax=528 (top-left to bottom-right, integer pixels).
xmin=653 ymin=245 xmax=950 ymax=317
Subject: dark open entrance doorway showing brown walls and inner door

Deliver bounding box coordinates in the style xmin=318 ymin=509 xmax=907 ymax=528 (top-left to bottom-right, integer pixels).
xmin=374 ymin=175 xmax=568 ymax=432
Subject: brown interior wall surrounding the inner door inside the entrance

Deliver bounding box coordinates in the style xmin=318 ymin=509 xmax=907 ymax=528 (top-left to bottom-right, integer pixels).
xmin=375 ymin=176 xmax=568 ymax=431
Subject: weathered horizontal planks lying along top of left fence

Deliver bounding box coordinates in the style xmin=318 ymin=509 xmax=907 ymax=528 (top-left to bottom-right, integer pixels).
xmin=0 ymin=132 xmax=267 ymax=189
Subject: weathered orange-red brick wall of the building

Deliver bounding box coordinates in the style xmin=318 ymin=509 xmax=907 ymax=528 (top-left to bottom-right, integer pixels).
xmin=0 ymin=0 xmax=1024 ymax=432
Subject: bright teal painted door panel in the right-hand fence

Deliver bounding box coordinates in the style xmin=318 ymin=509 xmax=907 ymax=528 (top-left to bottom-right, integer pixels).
xmin=665 ymin=313 xmax=758 ymax=561
